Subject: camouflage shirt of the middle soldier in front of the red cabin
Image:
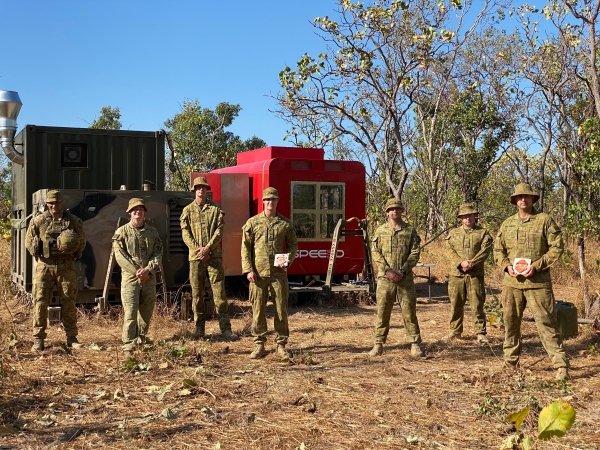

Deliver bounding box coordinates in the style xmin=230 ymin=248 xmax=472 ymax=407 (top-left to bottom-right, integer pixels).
xmin=242 ymin=212 xmax=298 ymax=277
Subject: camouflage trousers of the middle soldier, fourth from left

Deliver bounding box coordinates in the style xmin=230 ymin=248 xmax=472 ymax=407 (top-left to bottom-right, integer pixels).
xmin=250 ymin=275 xmax=290 ymax=345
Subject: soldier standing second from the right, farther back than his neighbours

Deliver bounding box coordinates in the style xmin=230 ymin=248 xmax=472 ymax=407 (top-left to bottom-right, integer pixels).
xmin=446 ymin=203 xmax=493 ymax=344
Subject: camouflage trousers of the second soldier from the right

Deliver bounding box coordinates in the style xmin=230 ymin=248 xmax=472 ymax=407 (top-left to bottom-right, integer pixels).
xmin=448 ymin=275 xmax=486 ymax=334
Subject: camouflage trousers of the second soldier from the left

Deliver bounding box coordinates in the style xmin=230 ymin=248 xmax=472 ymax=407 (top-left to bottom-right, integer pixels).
xmin=121 ymin=283 xmax=156 ymax=350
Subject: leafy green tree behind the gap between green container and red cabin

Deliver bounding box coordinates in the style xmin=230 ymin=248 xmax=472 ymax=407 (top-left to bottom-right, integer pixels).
xmin=165 ymin=100 xmax=267 ymax=190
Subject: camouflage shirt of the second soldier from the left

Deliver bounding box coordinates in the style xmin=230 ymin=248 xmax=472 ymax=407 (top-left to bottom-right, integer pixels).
xmin=112 ymin=222 xmax=162 ymax=285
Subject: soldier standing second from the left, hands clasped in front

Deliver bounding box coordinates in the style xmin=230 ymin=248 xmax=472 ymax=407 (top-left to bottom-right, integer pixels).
xmin=112 ymin=198 xmax=162 ymax=353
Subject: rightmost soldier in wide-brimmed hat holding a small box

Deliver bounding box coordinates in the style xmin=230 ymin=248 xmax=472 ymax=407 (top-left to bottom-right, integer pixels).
xmin=494 ymin=183 xmax=569 ymax=380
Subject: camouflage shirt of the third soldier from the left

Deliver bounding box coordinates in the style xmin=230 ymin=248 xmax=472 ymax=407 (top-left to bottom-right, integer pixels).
xmin=180 ymin=200 xmax=225 ymax=261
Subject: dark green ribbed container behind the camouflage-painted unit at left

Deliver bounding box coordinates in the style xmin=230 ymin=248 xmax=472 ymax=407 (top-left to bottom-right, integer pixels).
xmin=11 ymin=125 xmax=165 ymax=292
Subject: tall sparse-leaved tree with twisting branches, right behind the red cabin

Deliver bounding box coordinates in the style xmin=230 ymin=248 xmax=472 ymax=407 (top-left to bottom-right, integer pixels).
xmin=277 ymin=0 xmax=504 ymax=214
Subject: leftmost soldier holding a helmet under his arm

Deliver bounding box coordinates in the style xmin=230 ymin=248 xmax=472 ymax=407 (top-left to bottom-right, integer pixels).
xmin=25 ymin=191 xmax=85 ymax=351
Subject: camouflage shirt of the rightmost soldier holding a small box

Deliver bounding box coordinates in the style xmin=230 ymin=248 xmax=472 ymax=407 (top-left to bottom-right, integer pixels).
xmin=494 ymin=210 xmax=564 ymax=288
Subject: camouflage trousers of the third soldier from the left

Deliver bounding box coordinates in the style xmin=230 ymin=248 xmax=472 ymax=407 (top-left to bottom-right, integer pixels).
xmin=190 ymin=258 xmax=231 ymax=333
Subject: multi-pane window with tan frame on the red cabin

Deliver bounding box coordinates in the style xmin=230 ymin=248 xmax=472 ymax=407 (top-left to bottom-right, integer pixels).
xmin=291 ymin=181 xmax=346 ymax=241
